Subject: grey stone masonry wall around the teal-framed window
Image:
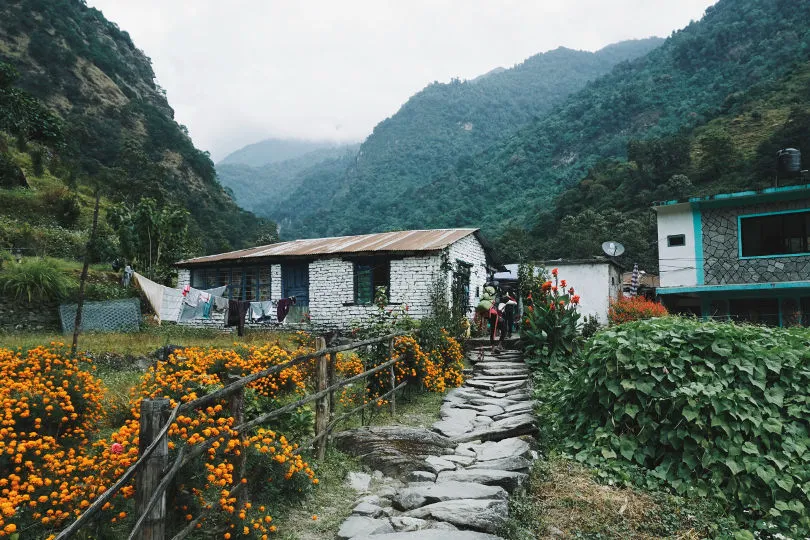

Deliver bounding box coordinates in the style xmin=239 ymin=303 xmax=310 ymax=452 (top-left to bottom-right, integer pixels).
xmin=698 ymin=200 xmax=810 ymax=285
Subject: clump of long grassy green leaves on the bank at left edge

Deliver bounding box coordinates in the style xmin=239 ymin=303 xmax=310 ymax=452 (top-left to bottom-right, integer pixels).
xmin=0 ymin=258 xmax=73 ymax=303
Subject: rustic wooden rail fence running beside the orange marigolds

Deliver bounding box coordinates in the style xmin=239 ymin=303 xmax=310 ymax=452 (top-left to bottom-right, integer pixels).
xmin=56 ymin=332 xmax=408 ymax=540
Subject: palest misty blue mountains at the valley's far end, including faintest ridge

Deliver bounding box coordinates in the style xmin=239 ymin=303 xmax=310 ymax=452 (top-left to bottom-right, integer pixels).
xmin=217 ymin=143 xmax=360 ymax=215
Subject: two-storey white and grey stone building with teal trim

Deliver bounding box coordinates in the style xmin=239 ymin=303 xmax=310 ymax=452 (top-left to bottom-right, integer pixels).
xmin=655 ymin=185 xmax=810 ymax=326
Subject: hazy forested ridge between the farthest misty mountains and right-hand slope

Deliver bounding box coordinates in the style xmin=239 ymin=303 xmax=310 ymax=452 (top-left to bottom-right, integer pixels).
xmin=267 ymin=38 xmax=662 ymax=236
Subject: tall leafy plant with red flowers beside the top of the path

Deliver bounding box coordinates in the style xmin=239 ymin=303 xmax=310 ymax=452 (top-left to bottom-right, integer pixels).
xmin=521 ymin=268 xmax=581 ymax=365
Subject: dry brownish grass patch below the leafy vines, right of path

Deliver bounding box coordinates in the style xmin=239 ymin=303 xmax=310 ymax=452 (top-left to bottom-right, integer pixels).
xmin=501 ymin=456 xmax=736 ymax=540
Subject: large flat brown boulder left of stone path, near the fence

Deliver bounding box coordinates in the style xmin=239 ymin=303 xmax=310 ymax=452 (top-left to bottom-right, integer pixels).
xmin=334 ymin=426 xmax=455 ymax=477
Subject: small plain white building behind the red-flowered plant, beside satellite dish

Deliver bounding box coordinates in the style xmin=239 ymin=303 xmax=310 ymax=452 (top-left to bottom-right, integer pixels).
xmin=494 ymin=257 xmax=622 ymax=324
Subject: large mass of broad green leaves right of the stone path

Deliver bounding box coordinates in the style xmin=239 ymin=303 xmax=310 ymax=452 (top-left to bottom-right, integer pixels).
xmin=560 ymin=317 xmax=810 ymax=537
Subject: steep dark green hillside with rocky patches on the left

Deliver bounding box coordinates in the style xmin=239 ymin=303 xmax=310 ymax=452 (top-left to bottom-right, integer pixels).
xmin=0 ymin=0 xmax=275 ymax=274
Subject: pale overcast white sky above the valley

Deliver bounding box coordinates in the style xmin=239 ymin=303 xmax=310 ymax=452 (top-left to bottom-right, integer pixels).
xmin=87 ymin=0 xmax=716 ymax=161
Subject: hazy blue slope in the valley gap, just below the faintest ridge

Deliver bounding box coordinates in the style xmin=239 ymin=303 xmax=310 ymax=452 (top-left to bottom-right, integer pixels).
xmin=217 ymin=141 xmax=360 ymax=215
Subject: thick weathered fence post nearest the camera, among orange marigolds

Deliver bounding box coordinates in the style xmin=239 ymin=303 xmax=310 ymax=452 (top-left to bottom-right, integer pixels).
xmin=135 ymin=398 xmax=171 ymax=540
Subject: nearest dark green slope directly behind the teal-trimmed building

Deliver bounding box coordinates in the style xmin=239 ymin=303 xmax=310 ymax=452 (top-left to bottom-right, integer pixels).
xmin=532 ymin=61 xmax=810 ymax=272
